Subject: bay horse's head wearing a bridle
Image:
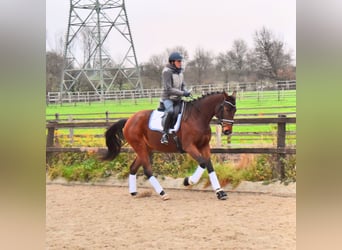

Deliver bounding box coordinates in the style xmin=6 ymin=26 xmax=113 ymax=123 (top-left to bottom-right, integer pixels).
xmin=215 ymin=91 xmax=236 ymax=135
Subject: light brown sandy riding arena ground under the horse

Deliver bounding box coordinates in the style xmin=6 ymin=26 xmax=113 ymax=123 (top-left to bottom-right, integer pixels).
xmin=46 ymin=184 xmax=296 ymax=250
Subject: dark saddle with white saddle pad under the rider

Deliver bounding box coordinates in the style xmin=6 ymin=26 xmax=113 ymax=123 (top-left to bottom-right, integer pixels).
xmin=148 ymin=101 xmax=184 ymax=133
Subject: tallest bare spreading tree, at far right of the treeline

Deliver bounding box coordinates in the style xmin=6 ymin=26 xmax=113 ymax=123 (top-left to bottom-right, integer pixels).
xmin=254 ymin=27 xmax=291 ymax=80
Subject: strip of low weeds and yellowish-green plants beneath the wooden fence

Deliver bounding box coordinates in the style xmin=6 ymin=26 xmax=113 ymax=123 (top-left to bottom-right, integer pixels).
xmin=47 ymin=152 xmax=296 ymax=187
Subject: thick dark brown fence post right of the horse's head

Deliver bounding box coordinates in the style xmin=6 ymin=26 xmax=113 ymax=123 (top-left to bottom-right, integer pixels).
xmin=276 ymin=115 xmax=286 ymax=180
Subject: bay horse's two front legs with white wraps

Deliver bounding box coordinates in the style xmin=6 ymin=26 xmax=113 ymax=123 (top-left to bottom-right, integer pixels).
xmin=184 ymin=146 xmax=228 ymax=200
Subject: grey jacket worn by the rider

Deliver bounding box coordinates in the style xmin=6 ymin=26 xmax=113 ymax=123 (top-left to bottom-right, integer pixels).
xmin=161 ymin=64 xmax=185 ymax=101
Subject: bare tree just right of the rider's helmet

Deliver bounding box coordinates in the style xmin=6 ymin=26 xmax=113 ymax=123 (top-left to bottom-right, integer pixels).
xmin=189 ymin=48 xmax=214 ymax=84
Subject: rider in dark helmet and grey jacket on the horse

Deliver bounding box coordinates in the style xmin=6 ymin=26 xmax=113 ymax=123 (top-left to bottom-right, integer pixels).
xmin=160 ymin=52 xmax=190 ymax=144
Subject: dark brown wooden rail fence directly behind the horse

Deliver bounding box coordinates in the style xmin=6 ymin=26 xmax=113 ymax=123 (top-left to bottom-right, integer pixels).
xmin=46 ymin=115 xmax=296 ymax=179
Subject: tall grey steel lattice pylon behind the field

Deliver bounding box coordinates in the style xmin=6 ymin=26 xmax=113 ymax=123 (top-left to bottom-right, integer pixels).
xmin=60 ymin=0 xmax=142 ymax=97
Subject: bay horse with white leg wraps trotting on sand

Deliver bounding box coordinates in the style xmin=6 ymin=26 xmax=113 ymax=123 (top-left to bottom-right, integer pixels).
xmin=103 ymin=91 xmax=236 ymax=200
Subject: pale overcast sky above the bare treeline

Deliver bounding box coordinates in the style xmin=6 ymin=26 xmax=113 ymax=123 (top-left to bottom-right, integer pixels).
xmin=46 ymin=0 xmax=296 ymax=63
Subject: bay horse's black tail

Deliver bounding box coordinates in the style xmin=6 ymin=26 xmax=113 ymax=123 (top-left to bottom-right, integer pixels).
xmin=102 ymin=119 xmax=127 ymax=160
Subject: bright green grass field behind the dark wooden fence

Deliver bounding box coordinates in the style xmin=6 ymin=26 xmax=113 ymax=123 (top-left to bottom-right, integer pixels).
xmin=46 ymin=90 xmax=296 ymax=146
